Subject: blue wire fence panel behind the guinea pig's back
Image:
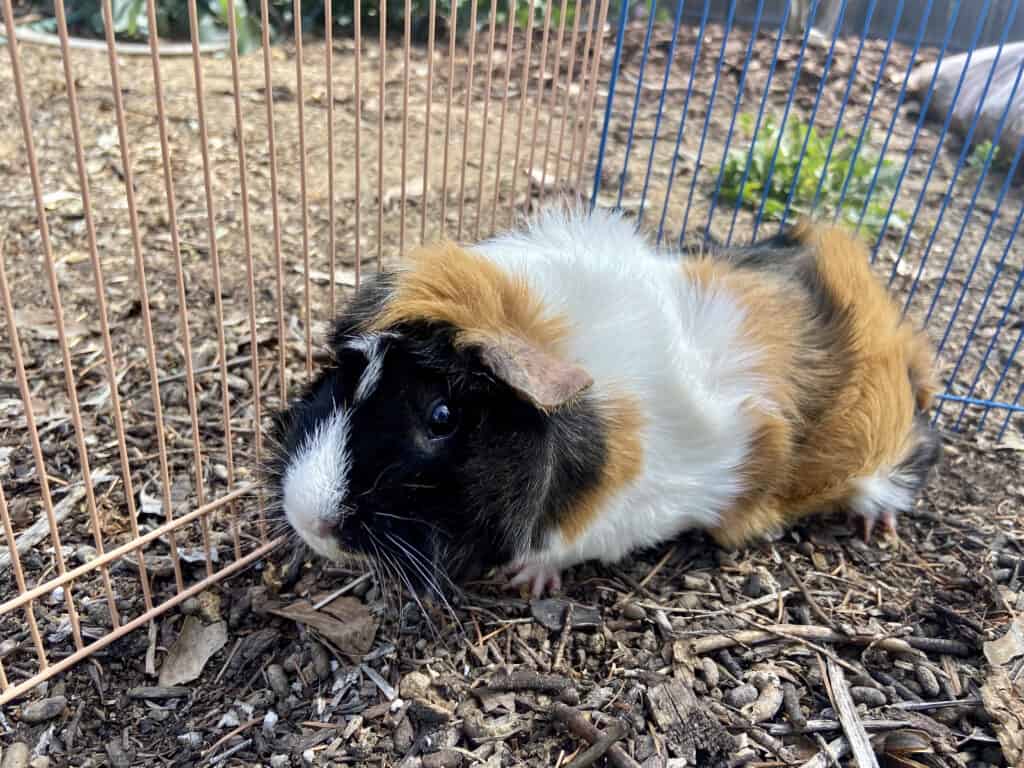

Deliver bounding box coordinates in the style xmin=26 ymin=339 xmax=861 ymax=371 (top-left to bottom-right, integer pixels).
xmin=592 ymin=0 xmax=1024 ymax=441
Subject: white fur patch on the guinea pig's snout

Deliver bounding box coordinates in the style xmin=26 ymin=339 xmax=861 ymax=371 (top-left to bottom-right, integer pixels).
xmin=282 ymin=409 xmax=351 ymax=560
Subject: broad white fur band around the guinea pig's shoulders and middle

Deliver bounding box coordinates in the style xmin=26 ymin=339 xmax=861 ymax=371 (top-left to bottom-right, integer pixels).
xmin=473 ymin=204 xmax=770 ymax=577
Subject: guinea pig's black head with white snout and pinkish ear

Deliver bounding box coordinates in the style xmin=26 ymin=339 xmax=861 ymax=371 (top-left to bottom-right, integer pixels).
xmin=273 ymin=262 xmax=591 ymax=590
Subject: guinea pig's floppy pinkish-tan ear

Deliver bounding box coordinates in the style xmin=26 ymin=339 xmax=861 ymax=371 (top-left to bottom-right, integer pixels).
xmin=480 ymin=337 xmax=594 ymax=411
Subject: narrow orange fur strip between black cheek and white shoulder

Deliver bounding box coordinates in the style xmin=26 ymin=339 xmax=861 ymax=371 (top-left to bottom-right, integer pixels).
xmin=558 ymin=396 xmax=644 ymax=543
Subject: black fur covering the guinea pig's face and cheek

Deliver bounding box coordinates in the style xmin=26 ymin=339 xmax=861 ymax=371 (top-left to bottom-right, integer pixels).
xmin=271 ymin=273 xmax=606 ymax=590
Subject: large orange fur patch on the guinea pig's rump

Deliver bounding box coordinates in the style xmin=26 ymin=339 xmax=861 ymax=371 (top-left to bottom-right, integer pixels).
xmin=704 ymin=224 xmax=935 ymax=546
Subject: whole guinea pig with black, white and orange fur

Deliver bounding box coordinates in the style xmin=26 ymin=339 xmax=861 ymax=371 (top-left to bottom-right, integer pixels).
xmin=273 ymin=207 xmax=941 ymax=595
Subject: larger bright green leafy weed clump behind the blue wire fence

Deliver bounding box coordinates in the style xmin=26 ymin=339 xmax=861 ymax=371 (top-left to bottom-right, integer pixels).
xmin=721 ymin=115 xmax=906 ymax=234
